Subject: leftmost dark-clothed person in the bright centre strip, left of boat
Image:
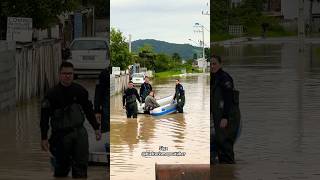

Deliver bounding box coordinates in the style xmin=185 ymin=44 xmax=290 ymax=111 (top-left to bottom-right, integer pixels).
xmin=122 ymin=81 xmax=141 ymax=118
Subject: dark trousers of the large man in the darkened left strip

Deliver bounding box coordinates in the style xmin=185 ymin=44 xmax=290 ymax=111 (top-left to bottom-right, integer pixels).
xmin=50 ymin=127 xmax=89 ymax=178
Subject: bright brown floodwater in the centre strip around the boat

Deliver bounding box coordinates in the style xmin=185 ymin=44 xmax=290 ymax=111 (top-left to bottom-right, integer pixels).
xmin=110 ymin=75 xmax=210 ymax=180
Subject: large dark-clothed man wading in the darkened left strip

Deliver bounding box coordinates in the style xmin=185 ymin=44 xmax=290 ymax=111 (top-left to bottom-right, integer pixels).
xmin=40 ymin=62 xmax=101 ymax=178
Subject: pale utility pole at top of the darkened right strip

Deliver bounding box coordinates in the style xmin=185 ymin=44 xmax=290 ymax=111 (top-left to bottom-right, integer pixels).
xmin=298 ymin=0 xmax=305 ymax=52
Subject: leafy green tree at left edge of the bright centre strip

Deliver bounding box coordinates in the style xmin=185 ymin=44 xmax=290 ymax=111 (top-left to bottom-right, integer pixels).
xmin=110 ymin=28 xmax=132 ymax=70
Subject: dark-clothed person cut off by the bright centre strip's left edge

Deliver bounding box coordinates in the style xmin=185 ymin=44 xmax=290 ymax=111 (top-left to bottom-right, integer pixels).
xmin=94 ymin=68 xmax=110 ymax=133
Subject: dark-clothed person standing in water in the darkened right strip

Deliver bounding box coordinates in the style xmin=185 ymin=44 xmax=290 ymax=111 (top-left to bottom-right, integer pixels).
xmin=210 ymin=55 xmax=240 ymax=164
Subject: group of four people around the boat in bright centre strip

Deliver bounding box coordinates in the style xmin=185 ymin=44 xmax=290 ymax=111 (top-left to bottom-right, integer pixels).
xmin=122 ymin=76 xmax=185 ymax=118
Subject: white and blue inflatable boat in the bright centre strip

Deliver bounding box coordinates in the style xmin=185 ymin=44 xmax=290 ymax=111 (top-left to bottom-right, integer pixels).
xmin=138 ymin=96 xmax=177 ymax=116
